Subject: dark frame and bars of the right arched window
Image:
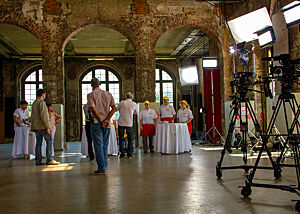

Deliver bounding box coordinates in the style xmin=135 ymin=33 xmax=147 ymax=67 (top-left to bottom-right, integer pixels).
xmin=155 ymin=65 xmax=177 ymax=106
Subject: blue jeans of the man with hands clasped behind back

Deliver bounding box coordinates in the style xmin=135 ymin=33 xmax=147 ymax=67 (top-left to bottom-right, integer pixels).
xmin=91 ymin=123 xmax=110 ymax=172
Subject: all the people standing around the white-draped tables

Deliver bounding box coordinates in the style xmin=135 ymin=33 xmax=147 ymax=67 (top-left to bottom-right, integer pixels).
xmin=14 ymin=78 xmax=193 ymax=175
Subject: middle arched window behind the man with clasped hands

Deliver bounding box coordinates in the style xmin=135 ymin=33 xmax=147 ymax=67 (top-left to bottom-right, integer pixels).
xmin=80 ymin=66 xmax=122 ymax=125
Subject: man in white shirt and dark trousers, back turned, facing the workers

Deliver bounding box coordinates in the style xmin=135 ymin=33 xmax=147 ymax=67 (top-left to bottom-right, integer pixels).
xmin=117 ymin=92 xmax=137 ymax=159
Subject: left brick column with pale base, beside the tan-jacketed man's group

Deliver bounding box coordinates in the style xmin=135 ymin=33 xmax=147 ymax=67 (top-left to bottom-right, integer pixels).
xmin=42 ymin=42 xmax=67 ymax=151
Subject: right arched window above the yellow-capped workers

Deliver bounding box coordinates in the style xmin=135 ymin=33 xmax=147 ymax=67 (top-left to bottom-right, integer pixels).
xmin=155 ymin=66 xmax=176 ymax=107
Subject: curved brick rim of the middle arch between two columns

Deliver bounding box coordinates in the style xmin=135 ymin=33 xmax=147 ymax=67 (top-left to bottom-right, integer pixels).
xmin=62 ymin=23 xmax=136 ymax=53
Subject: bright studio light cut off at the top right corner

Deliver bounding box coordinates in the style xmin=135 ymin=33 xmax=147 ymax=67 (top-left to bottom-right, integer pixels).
xmin=281 ymin=1 xmax=300 ymax=27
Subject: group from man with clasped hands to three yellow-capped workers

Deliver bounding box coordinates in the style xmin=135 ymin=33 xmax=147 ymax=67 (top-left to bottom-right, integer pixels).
xmin=84 ymin=78 xmax=193 ymax=175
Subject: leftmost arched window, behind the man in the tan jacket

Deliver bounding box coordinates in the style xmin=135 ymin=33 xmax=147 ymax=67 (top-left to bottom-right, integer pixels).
xmin=21 ymin=66 xmax=43 ymax=112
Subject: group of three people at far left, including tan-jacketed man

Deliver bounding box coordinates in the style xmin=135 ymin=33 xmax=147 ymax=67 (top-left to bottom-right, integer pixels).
xmin=13 ymin=89 xmax=62 ymax=165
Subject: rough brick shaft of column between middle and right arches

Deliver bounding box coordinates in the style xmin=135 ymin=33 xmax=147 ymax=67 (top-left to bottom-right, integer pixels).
xmin=134 ymin=36 xmax=156 ymax=102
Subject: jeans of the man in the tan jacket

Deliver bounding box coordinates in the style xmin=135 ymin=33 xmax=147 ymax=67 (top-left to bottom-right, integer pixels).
xmin=34 ymin=129 xmax=53 ymax=164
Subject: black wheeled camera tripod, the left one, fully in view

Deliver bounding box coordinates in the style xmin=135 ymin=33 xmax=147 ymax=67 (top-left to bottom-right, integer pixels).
xmin=216 ymin=92 xmax=278 ymax=179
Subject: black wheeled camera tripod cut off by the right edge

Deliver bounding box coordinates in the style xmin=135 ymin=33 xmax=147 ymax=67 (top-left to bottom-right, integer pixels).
xmin=241 ymin=89 xmax=300 ymax=211
